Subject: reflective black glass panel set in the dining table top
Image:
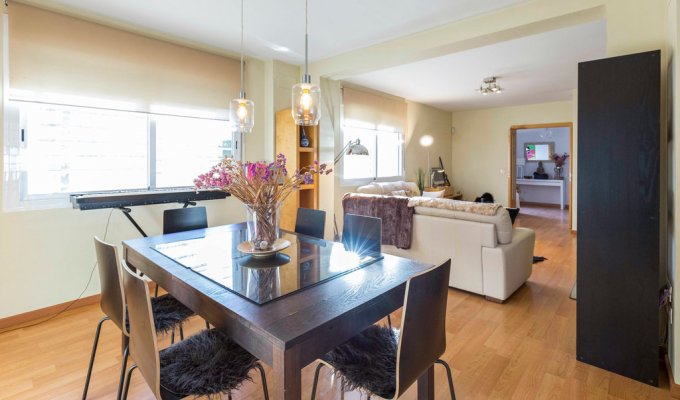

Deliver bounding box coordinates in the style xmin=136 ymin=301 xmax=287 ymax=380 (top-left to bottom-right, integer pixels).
xmin=152 ymin=227 xmax=383 ymax=304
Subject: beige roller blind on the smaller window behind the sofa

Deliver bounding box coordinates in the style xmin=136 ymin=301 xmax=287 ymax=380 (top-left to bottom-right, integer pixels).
xmin=342 ymin=87 xmax=406 ymax=132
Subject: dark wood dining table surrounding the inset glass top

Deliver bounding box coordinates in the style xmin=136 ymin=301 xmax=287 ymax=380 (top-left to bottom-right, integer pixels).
xmin=123 ymin=224 xmax=434 ymax=400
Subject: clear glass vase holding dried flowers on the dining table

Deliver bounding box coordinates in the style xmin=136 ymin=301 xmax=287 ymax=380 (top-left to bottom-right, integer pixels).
xmin=245 ymin=202 xmax=281 ymax=251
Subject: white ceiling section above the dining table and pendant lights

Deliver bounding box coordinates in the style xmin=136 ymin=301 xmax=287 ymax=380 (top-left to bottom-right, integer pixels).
xmin=30 ymin=0 xmax=523 ymax=64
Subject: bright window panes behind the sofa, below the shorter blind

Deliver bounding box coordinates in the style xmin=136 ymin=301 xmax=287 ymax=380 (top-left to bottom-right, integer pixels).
xmin=343 ymin=125 xmax=404 ymax=181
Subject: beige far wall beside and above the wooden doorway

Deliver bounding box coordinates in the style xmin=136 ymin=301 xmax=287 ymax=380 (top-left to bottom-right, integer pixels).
xmin=451 ymin=101 xmax=574 ymax=205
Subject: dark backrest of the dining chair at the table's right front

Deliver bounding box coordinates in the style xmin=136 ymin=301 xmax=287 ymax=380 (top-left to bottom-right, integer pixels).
xmin=394 ymin=260 xmax=451 ymax=399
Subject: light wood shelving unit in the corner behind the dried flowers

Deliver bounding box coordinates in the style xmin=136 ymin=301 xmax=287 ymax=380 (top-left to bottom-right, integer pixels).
xmin=276 ymin=108 xmax=319 ymax=231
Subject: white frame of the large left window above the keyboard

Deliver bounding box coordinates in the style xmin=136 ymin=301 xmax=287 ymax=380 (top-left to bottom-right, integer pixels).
xmin=2 ymin=98 xmax=243 ymax=212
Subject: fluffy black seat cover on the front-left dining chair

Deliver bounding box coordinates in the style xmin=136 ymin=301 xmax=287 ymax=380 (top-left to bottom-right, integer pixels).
xmin=160 ymin=329 xmax=257 ymax=396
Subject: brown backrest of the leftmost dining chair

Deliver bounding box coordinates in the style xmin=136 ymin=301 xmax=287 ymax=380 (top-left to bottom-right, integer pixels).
xmin=94 ymin=236 xmax=127 ymax=335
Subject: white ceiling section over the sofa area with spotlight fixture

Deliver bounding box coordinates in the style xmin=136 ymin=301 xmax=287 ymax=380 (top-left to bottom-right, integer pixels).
xmin=345 ymin=21 xmax=606 ymax=111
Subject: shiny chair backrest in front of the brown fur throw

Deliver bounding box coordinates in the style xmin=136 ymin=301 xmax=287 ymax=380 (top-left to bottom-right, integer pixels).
xmin=342 ymin=214 xmax=382 ymax=253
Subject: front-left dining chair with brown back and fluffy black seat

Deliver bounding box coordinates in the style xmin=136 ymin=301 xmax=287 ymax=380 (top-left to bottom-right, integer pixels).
xmin=122 ymin=263 xmax=269 ymax=400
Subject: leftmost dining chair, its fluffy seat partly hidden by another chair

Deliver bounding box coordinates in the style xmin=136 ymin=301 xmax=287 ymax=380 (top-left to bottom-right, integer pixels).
xmin=83 ymin=237 xmax=194 ymax=400
